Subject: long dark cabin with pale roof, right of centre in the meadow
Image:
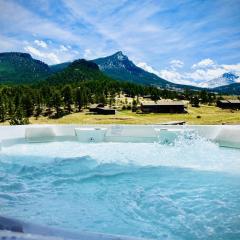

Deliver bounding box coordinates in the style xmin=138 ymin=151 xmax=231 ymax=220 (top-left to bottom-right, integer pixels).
xmin=141 ymin=101 xmax=185 ymax=113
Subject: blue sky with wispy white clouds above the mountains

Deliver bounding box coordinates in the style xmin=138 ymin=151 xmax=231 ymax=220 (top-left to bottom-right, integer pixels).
xmin=0 ymin=0 xmax=240 ymax=85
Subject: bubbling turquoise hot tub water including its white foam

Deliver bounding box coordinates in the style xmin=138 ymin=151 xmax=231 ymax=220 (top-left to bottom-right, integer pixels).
xmin=0 ymin=139 xmax=240 ymax=240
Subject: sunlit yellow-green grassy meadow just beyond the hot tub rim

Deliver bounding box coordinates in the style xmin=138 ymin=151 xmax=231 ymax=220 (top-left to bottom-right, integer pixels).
xmin=13 ymin=105 xmax=240 ymax=124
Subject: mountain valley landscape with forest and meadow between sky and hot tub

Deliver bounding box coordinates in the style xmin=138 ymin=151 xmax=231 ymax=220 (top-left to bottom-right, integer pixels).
xmin=0 ymin=52 xmax=240 ymax=125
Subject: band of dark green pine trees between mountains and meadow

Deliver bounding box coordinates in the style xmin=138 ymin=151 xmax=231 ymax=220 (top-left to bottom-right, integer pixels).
xmin=0 ymin=79 xmax=216 ymax=125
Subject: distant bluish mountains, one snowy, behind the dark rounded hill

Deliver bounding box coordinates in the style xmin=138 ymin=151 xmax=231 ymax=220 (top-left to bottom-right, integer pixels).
xmin=0 ymin=51 xmax=240 ymax=93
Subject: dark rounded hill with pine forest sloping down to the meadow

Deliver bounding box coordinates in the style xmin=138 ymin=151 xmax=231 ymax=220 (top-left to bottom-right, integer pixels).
xmin=0 ymin=60 xmax=183 ymax=124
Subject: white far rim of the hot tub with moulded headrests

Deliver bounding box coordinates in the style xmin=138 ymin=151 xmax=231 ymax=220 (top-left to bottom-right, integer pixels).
xmin=0 ymin=125 xmax=240 ymax=148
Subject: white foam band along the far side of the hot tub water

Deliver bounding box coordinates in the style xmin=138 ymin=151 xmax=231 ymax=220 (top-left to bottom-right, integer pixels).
xmin=0 ymin=137 xmax=240 ymax=174
